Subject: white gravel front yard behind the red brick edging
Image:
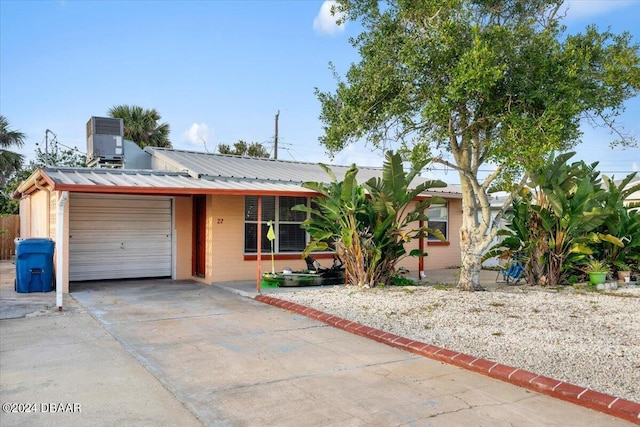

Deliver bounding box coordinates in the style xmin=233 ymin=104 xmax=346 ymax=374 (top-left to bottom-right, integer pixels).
xmin=274 ymin=286 xmax=640 ymax=402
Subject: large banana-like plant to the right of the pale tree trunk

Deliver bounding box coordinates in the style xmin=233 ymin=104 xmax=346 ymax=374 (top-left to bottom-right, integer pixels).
xmin=484 ymin=153 xmax=624 ymax=286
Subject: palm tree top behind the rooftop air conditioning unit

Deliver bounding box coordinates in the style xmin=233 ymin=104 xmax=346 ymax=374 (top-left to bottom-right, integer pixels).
xmin=108 ymin=105 xmax=172 ymax=148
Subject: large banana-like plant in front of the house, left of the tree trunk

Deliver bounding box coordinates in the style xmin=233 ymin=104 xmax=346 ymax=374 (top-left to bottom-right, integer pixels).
xmin=293 ymin=151 xmax=446 ymax=288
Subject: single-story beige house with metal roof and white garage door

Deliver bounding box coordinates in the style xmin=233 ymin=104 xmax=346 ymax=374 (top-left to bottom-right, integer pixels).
xmin=14 ymin=144 xmax=462 ymax=293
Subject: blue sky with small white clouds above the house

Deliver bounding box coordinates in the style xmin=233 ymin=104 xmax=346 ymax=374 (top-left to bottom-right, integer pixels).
xmin=0 ymin=0 xmax=640 ymax=183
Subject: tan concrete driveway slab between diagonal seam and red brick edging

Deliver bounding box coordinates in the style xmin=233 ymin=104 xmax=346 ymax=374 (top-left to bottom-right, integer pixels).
xmin=73 ymin=280 xmax=636 ymax=426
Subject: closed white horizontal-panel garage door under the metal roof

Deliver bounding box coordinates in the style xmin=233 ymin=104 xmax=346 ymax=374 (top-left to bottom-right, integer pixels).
xmin=69 ymin=194 xmax=172 ymax=281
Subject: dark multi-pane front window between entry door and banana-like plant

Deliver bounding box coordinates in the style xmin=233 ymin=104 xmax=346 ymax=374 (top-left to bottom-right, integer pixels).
xmin=244 ymin=196 xmax=307 ymax=253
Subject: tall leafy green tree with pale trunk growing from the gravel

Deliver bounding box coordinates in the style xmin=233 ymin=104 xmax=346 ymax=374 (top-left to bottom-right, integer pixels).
xmin=317 ymin=0 xmax=640 ymax=290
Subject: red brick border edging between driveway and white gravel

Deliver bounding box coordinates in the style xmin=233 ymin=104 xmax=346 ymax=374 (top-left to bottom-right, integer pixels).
xmin=255 ymin=294 xmax=640 ymax=424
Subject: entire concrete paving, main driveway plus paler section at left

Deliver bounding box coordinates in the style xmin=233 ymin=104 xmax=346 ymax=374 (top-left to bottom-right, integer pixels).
xmin=0 ymin=262 xmax=630 ymax=426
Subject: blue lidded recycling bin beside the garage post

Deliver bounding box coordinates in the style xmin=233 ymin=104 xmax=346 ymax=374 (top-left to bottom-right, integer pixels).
xmin=14 ymin=238 xmax=55 ymax=293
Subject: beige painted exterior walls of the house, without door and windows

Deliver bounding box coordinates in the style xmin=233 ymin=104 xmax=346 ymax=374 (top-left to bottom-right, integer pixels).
xmin=20 ymin=191 xmax=462 ymax=293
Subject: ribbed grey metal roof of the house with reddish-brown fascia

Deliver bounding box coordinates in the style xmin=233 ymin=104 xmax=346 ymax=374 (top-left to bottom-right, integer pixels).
xmin=14 ymin=147 xmax=461 ymax=198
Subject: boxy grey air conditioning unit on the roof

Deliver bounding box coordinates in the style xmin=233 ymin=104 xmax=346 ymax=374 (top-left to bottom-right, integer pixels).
xmin=87 ymin=117 xmax=124 ymax=161
